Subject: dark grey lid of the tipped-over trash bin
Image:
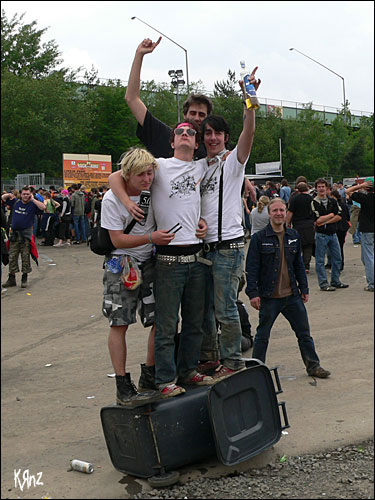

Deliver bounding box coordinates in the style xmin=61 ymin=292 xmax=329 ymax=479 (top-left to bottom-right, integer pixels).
xmin=207 ymin=364 xmax=281 ymax=465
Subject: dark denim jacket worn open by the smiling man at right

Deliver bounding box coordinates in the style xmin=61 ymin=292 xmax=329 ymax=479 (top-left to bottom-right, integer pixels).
xmin=245 ymin=223 xmax=309 ymax=299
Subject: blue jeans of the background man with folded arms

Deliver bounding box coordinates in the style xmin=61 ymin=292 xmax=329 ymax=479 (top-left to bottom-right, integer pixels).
xmin=315 ymin=233 xmax=342 ymax=288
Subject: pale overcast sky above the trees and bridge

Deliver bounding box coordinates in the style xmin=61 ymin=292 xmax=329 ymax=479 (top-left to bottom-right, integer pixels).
xmin=2 ymin=1 xmax=374 ymax=112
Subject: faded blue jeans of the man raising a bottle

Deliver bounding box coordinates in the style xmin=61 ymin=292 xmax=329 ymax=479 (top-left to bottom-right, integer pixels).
xmin=200 ymin=248 xmax=245 ymax=370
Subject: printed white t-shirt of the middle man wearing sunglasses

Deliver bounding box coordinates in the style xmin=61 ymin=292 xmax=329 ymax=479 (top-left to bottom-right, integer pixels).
xmin=151 ymin=154 xmax=207 ymax=245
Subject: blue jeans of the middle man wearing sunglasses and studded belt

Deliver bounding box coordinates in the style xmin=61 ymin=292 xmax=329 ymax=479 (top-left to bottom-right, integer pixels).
xmin=154 ymin=261 xmax=205 ymax=387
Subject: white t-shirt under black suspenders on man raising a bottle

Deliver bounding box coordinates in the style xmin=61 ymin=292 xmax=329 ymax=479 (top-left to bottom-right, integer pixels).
xmin=201 ymin=146 xmax=247 ymax=243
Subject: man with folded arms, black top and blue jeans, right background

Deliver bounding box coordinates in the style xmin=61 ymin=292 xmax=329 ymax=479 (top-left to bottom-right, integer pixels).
xmin=311 ymin=178 xmax=349 ymax=292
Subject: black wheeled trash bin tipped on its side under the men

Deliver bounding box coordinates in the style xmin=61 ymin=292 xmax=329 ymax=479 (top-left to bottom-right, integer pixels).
xmin=101 ymin=359 xmax=289 ymax=486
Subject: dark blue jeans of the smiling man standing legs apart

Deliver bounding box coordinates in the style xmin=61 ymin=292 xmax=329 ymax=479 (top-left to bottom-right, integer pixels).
xmin=253 ymin=295 xmax=320 ymax=372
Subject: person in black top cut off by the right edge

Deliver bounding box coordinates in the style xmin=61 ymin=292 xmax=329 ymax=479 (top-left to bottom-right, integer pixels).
xmin=346 ymin=177 xmax=374 ymax=292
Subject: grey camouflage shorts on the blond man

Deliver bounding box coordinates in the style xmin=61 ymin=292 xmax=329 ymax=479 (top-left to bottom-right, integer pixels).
xmin=102 ymin=260 xmax=155 ymax=328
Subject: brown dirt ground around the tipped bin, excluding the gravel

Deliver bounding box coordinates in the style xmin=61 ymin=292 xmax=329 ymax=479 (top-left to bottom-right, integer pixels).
xmin=1 ymin=237 xmax=374 ymax=498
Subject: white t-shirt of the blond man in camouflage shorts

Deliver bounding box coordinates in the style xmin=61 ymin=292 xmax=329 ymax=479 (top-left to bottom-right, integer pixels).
xmin=101 ymin=189 xmax=156 ymax=262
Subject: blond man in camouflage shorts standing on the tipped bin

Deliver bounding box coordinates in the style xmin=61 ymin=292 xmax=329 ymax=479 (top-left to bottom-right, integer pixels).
xmin=101 ymin=148 xmax=175 ymax=407
